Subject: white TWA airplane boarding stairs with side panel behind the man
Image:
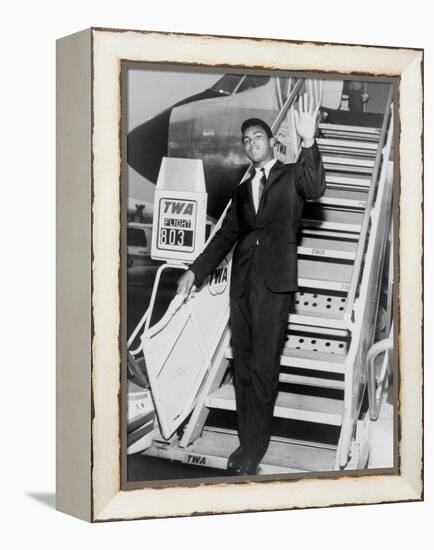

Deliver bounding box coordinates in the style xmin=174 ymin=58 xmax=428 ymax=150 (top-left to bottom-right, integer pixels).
xmin=130 ymin=84 xmax=393 ymax=474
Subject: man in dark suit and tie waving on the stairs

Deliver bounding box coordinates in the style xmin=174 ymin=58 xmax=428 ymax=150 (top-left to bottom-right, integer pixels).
xmin=178 ymin=95 xmax=325 ymax=475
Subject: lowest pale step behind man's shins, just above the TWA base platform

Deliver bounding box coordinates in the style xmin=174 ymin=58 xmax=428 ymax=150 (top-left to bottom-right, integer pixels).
xmin=205 ymin=384 xmax=344 ymax=426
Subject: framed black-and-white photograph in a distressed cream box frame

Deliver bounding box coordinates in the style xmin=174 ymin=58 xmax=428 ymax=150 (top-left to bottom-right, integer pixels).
xmin=57 ymin=28 xmax=423 ymax=522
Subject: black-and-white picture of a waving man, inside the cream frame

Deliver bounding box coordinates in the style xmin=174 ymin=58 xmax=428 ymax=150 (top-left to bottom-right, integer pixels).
xmin=121 ymin=67 xmax=399 ymax=489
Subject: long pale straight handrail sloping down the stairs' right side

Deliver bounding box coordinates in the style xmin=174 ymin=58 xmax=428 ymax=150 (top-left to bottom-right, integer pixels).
xmin=344 ymin=86 xmax=393 ymax=329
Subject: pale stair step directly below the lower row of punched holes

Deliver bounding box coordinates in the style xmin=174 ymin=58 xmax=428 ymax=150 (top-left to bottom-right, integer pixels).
xmin=225 ymin=347 xmax=346 ymax=378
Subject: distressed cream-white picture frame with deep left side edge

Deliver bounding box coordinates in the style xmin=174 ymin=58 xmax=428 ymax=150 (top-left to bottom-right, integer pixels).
xmin=57 ymin=28 xmax=423 ymax=522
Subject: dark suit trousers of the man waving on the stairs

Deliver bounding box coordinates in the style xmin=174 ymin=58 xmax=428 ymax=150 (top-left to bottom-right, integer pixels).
xmin=231 ymin=260 xmax=292 ymax=461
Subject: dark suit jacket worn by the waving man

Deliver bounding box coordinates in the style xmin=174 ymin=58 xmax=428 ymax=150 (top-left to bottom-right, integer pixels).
xmin=190 ymin=142 xmax=325 ymax=296
